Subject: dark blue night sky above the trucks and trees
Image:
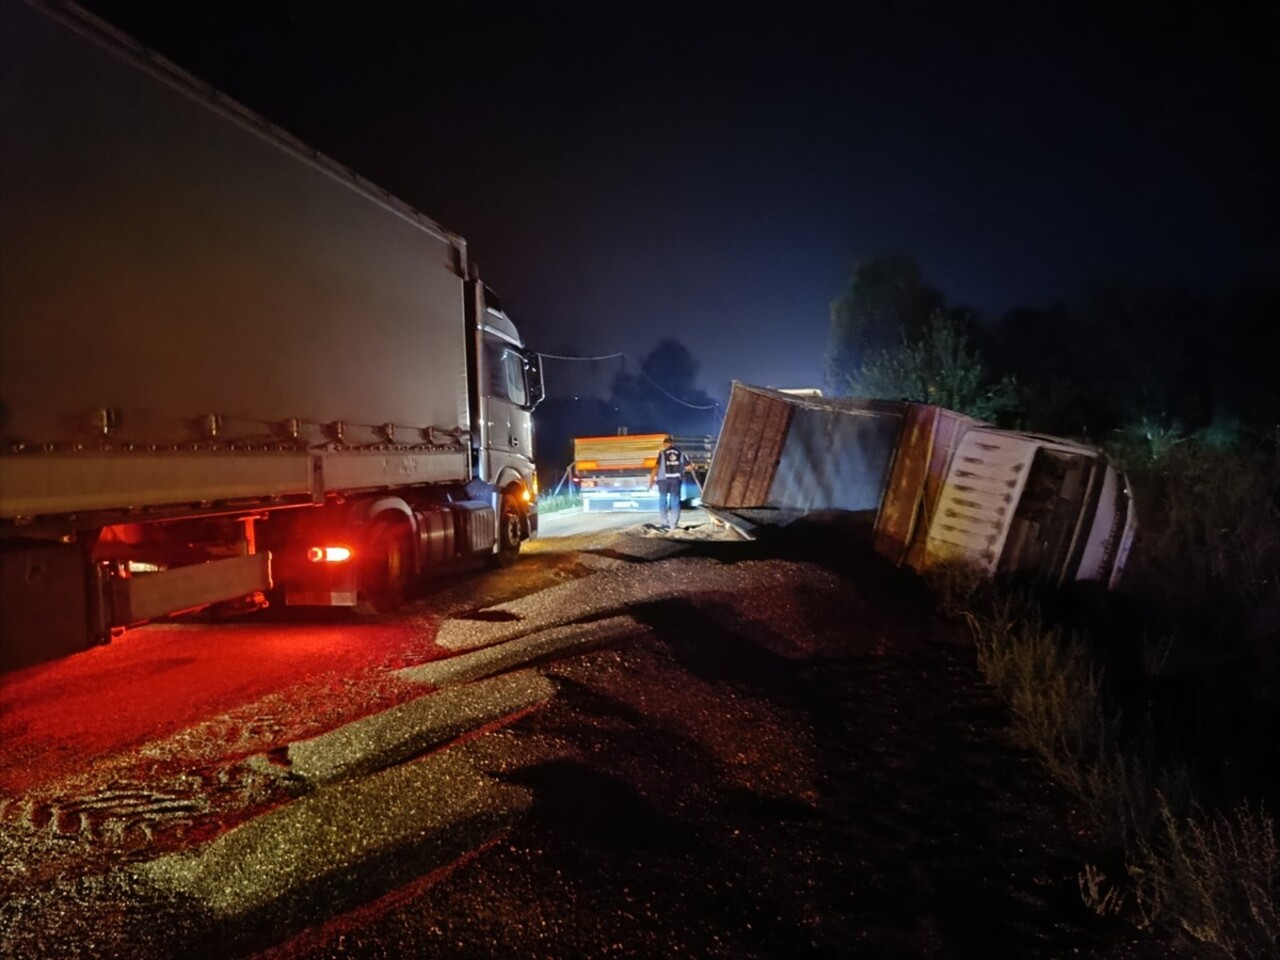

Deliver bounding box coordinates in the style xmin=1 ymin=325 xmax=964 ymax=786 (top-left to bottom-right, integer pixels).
xmin=72 ymin=0 xmax=1280 ymax=397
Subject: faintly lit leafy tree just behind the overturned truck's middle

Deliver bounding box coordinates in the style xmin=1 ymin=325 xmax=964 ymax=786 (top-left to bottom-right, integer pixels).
xmin=846 ymin=310 xmax=1018 ymax=420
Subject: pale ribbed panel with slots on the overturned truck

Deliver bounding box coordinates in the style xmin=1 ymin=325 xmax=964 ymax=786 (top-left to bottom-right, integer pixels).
xmin=925 ymin=429 xmax=1039 ymax=573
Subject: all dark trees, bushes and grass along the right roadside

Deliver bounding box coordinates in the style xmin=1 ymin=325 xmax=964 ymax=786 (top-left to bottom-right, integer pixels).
xmin=828 ymin=257 xmax=1280 ymax=957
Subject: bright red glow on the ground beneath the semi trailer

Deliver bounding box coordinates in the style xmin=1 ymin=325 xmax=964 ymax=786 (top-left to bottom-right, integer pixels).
xmin=0 ymin=623 xmax=431 ymax=794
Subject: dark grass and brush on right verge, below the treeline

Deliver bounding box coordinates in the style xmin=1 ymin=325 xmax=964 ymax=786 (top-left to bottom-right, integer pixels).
xmin=937 ymin=445 xmax=1280 ymax=959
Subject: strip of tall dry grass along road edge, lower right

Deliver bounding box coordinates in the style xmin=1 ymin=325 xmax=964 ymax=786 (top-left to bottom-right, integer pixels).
xmin=946 ymin=584 xmax=1280 ymax=957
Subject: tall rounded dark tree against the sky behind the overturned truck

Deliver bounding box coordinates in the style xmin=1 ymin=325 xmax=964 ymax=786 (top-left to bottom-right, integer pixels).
xmin=826 ymin=256 xmax=945 ymax=393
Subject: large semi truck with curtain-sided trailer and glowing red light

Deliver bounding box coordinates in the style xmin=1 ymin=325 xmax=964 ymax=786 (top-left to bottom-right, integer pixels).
xmin=0 ymin=0 xmax=543 ymax=668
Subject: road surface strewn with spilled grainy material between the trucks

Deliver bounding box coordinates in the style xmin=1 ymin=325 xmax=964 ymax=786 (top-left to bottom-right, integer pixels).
xmin=0 ymin=513 xmax=1171 ymax=957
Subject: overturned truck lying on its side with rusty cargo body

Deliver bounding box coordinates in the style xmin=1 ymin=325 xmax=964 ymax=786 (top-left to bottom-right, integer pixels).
xmin=703 ymin=383 xmax=1137 ymax=588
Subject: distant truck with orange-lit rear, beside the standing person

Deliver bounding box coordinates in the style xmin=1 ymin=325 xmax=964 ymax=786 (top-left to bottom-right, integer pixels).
xmin=570 ymin=434 xmax=714 ymax=513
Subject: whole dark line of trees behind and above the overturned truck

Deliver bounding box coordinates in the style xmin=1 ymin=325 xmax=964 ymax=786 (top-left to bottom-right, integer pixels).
xmin=826 ymin=255 xmax=1280 ymax=442
